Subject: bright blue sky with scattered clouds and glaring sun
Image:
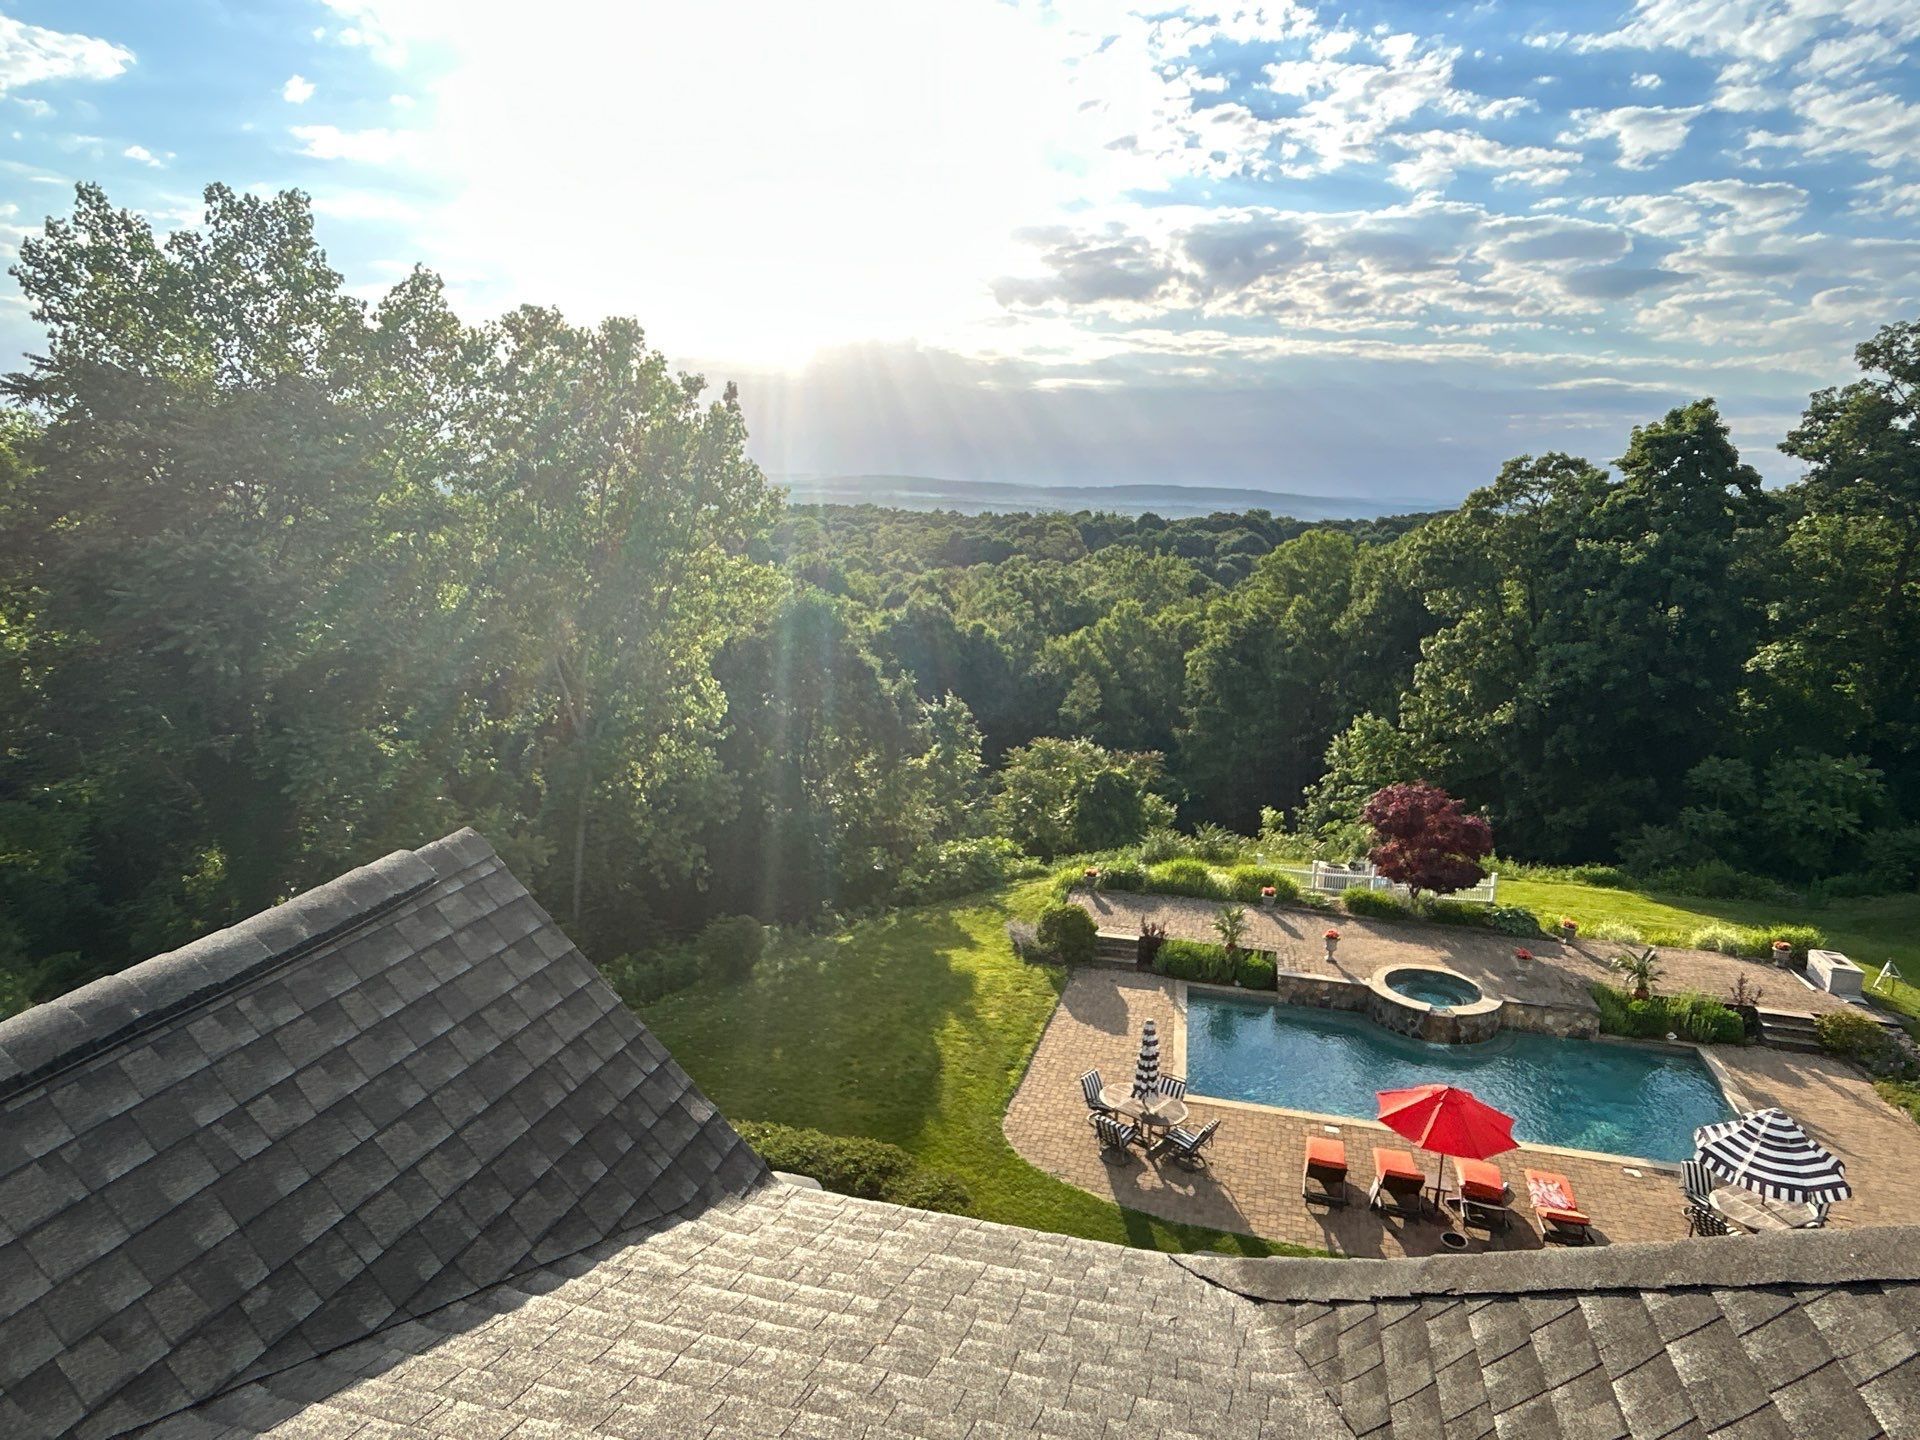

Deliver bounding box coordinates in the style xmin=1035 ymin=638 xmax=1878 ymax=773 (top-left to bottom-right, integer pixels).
xmin=0 ymin=0 xmax=1920 ymax=501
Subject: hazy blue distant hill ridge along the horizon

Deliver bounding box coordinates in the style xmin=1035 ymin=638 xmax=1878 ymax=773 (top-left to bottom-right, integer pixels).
xmin=778 ymin=474 xmax=1438 ymax=520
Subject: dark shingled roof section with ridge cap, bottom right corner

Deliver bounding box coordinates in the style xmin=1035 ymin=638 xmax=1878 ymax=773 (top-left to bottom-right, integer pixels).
xmin=1183 ymin=1227 xmax=1920 ymax=1440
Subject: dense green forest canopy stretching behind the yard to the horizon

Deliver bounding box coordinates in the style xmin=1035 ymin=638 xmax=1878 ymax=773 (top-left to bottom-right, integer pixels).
xmin=0 ymin=186 xmax=1920 ymax=1012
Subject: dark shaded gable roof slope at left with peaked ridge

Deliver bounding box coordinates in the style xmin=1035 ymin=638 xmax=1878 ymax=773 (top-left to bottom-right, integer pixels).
xmin=0 ymin=831 xmax=764 ymax=1440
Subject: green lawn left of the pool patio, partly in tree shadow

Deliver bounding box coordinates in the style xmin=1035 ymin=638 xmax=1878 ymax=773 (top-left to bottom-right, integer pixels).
xmin=643 ymin=883 xmax=1309 ymax=1256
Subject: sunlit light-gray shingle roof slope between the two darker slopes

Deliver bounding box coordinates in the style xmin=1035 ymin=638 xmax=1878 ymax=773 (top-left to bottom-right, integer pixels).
xmin=127 ymin=1183 xmax=1348 ymax=1440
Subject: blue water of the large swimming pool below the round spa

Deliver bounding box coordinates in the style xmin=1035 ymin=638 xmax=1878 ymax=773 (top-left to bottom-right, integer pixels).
xmin=1187 ymin=991 xmax=1734 ymax=1160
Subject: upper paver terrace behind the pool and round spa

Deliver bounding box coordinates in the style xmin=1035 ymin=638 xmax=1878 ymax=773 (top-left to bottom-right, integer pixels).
xmin=1073 ymin=891 xmax=1847 ymax=1016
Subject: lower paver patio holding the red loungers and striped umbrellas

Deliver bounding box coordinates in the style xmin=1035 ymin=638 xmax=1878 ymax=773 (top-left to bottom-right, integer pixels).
xmin=1004 ymin=971 xmax=1920 ymax=1256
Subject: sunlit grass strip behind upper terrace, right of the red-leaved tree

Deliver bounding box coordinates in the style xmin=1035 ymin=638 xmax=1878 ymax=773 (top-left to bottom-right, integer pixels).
xmin=1500 ymin=879 xmax=1920 ymax=1016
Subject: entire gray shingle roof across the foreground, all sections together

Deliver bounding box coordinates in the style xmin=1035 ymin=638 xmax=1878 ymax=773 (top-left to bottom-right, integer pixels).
xmin=0 ymin=831 xmax=1920 ymax=1440
